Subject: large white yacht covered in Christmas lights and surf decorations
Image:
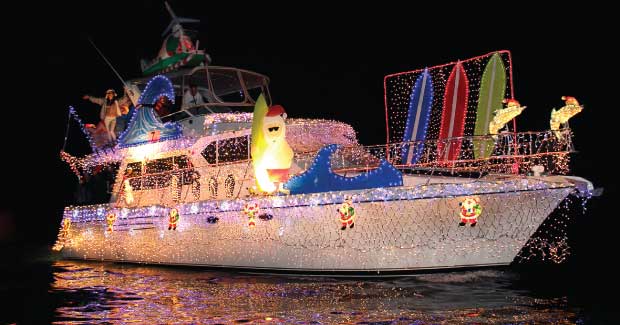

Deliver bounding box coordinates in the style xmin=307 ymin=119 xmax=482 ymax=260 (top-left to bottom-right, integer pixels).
xmin=54 ymin=5 xmax=594 ymax=275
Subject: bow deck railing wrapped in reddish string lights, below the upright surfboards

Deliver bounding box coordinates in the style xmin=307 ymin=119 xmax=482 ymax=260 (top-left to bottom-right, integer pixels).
xmin=296 ymin=129 xmax=574 ymax=175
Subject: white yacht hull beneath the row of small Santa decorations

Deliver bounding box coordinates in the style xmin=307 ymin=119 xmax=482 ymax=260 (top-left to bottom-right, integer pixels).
xmin=62 ymin=181 xmax=573 ymax=273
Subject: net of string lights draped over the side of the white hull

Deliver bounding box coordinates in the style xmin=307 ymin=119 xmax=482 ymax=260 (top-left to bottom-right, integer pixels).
xmin=55 ymin=178 xmax=573 ymax=270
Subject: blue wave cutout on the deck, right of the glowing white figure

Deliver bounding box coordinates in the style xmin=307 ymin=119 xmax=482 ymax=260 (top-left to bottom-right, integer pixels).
xmin=284 ymin=144 xmax=403 ymax=194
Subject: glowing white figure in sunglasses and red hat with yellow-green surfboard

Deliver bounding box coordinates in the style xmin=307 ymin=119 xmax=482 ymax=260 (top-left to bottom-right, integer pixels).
xmin=250 ymin=94 xmax=293 ymax=194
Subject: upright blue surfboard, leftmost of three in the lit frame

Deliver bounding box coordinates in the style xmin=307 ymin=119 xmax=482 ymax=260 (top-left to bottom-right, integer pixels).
xmin=401 ymin=68 xmax=433 ymax=165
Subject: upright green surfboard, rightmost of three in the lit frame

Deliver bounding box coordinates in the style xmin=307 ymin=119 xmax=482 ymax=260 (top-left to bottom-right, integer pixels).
xmin=474 ymin=53 xmax=506 ymax=159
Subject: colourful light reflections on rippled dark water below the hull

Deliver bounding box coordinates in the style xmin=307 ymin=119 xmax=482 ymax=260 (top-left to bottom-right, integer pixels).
xmin=51 ymin=261 xmax=580 ymax=324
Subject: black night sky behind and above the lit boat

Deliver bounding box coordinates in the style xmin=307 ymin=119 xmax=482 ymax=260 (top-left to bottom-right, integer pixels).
xmin=0 ymin=0 xmax=618 ymax=270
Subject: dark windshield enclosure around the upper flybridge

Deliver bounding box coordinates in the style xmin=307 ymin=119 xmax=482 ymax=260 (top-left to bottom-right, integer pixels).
xmin=127 ymin=66 xmax=271 ymax=121
